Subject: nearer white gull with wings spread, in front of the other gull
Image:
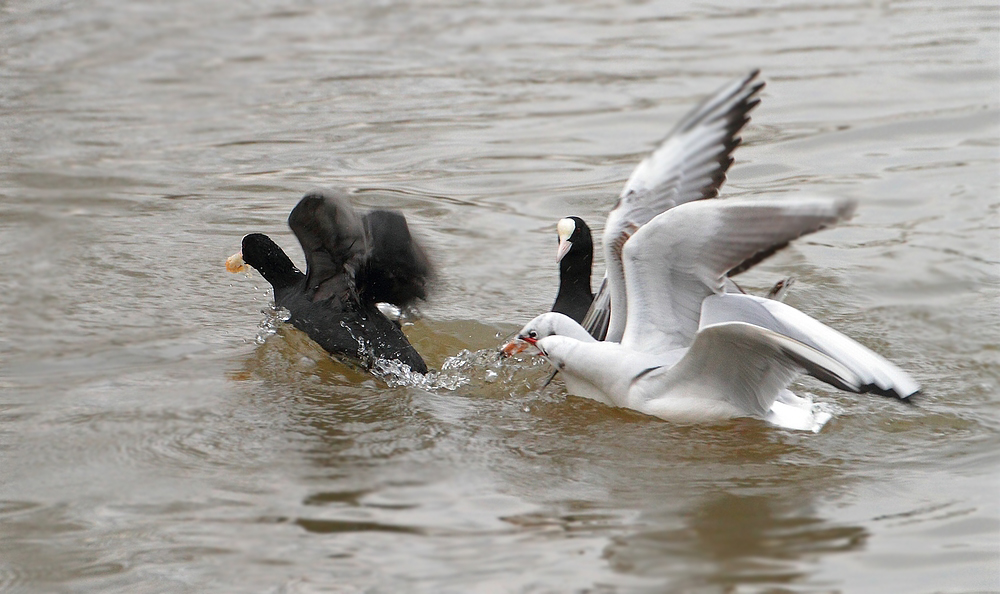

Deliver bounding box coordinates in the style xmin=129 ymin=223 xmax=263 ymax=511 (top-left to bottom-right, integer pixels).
xmin=505 ymin=197 xmax=919 ymax=431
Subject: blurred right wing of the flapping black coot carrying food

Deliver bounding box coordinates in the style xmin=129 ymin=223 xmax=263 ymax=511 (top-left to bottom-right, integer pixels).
xmin=364 ymin=210 xmax=431 ymax=307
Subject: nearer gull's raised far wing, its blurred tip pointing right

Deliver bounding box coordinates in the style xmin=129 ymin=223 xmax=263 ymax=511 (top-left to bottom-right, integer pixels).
xmin=612 ymin=197 xmax=855 ymax=354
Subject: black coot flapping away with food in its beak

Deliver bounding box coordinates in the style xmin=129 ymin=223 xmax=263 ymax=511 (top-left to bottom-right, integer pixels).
xmin=242 ymin=191 xmax=430 ymax=373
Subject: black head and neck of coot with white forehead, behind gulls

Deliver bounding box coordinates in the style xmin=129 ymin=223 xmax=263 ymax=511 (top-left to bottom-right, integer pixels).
xmin=552 ymin=217 xmax=594 ymax=323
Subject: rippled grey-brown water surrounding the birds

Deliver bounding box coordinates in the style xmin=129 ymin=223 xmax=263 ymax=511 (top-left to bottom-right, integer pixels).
xmin=0 ymin=0 xmax=1000 ymax=593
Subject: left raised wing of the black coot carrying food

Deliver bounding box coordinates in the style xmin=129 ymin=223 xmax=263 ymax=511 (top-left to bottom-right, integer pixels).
xmin=288 ymin=191 xmax=366 ymax=302
